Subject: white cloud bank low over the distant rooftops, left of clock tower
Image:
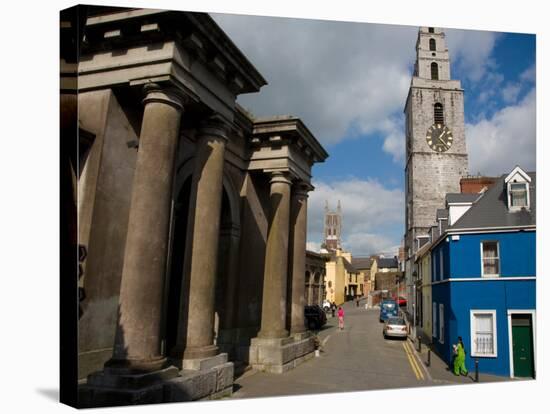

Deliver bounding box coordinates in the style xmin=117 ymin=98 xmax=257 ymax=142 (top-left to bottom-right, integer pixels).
xmin=308 ymin=178 xmax=404 ymax=255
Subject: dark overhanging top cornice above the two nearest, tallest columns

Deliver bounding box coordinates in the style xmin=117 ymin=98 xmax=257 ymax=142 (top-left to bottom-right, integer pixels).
xmin=83 ymin=9 xmax=267 ymax=95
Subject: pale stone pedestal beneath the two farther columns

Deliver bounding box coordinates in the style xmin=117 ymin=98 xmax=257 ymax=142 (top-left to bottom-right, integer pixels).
xmin=249 ymin=333 xmax=315 ymax=374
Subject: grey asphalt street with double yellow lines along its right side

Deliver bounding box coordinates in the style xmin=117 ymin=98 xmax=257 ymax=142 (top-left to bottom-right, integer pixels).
xmin=232 ymin=303 xmax=432 ymax=398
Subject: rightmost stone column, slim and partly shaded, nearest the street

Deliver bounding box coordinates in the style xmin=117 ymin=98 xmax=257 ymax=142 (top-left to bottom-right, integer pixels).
xmin=289 ymin=183 xmax=311 ymax=334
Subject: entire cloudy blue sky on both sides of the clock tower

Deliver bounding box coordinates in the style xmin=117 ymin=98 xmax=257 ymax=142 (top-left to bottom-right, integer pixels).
xmin=212 ymin=14 xmax=536 ymax=256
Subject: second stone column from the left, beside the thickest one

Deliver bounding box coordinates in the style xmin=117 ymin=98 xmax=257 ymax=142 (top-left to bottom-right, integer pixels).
xmin=183 ymin=116 xmax=228 ymax=359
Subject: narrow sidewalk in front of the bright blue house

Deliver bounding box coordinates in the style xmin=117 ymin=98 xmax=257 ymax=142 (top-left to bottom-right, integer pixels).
xmin=409 ymin=336 xmax=512 ymax=384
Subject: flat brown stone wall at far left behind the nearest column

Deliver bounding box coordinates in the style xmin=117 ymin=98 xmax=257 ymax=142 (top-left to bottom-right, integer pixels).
xmin=79 ymin=90 xmax=139 ymax=378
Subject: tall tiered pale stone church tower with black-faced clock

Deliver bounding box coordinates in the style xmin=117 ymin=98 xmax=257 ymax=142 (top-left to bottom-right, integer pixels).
xmin=405 ymin=27 xmax=468 ymax=266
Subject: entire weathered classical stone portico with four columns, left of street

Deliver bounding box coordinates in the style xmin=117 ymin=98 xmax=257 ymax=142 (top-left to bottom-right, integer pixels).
xmin=68 ymin=7 xmax=328 ymax=406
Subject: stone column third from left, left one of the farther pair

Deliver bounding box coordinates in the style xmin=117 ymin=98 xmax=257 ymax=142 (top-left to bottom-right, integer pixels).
xmin=258 ymin=172 xmax=291 ymax=339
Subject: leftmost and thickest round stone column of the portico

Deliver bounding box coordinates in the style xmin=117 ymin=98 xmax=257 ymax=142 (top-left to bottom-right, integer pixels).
xmin=105 ymin=84 xmax=183 ymax=372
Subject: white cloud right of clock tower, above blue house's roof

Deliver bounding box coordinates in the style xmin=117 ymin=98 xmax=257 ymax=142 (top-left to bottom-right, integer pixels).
xmin=466 ymin=88 xmax=536 ymax=175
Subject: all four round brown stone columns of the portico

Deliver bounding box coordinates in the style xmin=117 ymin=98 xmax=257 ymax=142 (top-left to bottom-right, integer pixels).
xmin=105 ymin=84 xmax=312 ymax=374
